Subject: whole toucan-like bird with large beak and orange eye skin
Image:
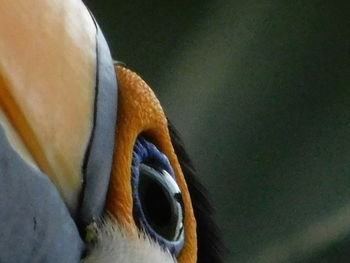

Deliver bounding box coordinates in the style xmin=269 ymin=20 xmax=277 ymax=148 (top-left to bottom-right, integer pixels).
xmin=0 ymin=0 xmax=223 ymax=263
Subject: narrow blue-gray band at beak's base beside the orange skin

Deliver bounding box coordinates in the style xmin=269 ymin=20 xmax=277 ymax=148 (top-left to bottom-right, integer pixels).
xmin=79 ymin=19 xmax=118 ymax=225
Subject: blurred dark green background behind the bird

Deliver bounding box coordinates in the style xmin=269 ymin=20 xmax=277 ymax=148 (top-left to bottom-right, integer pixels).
xmin=85 ymin=0 xmax=350 ymax=263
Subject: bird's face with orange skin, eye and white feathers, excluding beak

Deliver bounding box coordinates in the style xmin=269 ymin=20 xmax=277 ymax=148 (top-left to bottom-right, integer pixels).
xmin=80 ymin=67 xmax=196 ymax=262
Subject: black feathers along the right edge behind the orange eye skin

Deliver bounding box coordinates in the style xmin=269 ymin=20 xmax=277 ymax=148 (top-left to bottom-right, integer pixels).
xmin=168 ymin=121 xmax=226 ymax=263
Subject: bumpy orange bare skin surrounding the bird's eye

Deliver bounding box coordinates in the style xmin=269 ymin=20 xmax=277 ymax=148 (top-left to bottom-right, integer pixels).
xmin=106 ymin=66 xmax=197 ymax=263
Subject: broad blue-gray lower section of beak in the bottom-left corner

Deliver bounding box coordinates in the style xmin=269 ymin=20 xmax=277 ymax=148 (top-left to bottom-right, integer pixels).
xmin=0 ymin=126 xmax=84 ymax=263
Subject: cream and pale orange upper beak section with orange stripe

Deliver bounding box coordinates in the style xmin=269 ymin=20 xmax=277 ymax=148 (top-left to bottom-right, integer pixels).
xmin=0 ymin=0 xmax=96 ymax=212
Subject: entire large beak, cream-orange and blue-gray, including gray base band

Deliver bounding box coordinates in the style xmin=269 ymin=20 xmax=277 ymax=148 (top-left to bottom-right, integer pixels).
xmin=0 ymin=0 xmax=117 ymax=263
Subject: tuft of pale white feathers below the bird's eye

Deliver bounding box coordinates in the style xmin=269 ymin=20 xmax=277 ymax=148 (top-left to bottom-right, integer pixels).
xmin=81 ymin=220 xmax=177 ymax=263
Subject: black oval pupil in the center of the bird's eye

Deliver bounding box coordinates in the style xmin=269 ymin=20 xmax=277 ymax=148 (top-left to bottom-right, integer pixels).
xmin=139 ymin=169 xmax=177 ymax=240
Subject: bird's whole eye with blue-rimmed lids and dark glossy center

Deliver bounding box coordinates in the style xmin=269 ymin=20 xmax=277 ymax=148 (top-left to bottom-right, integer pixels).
xmin=132 ymin=137 xmax=184 ymax=255
